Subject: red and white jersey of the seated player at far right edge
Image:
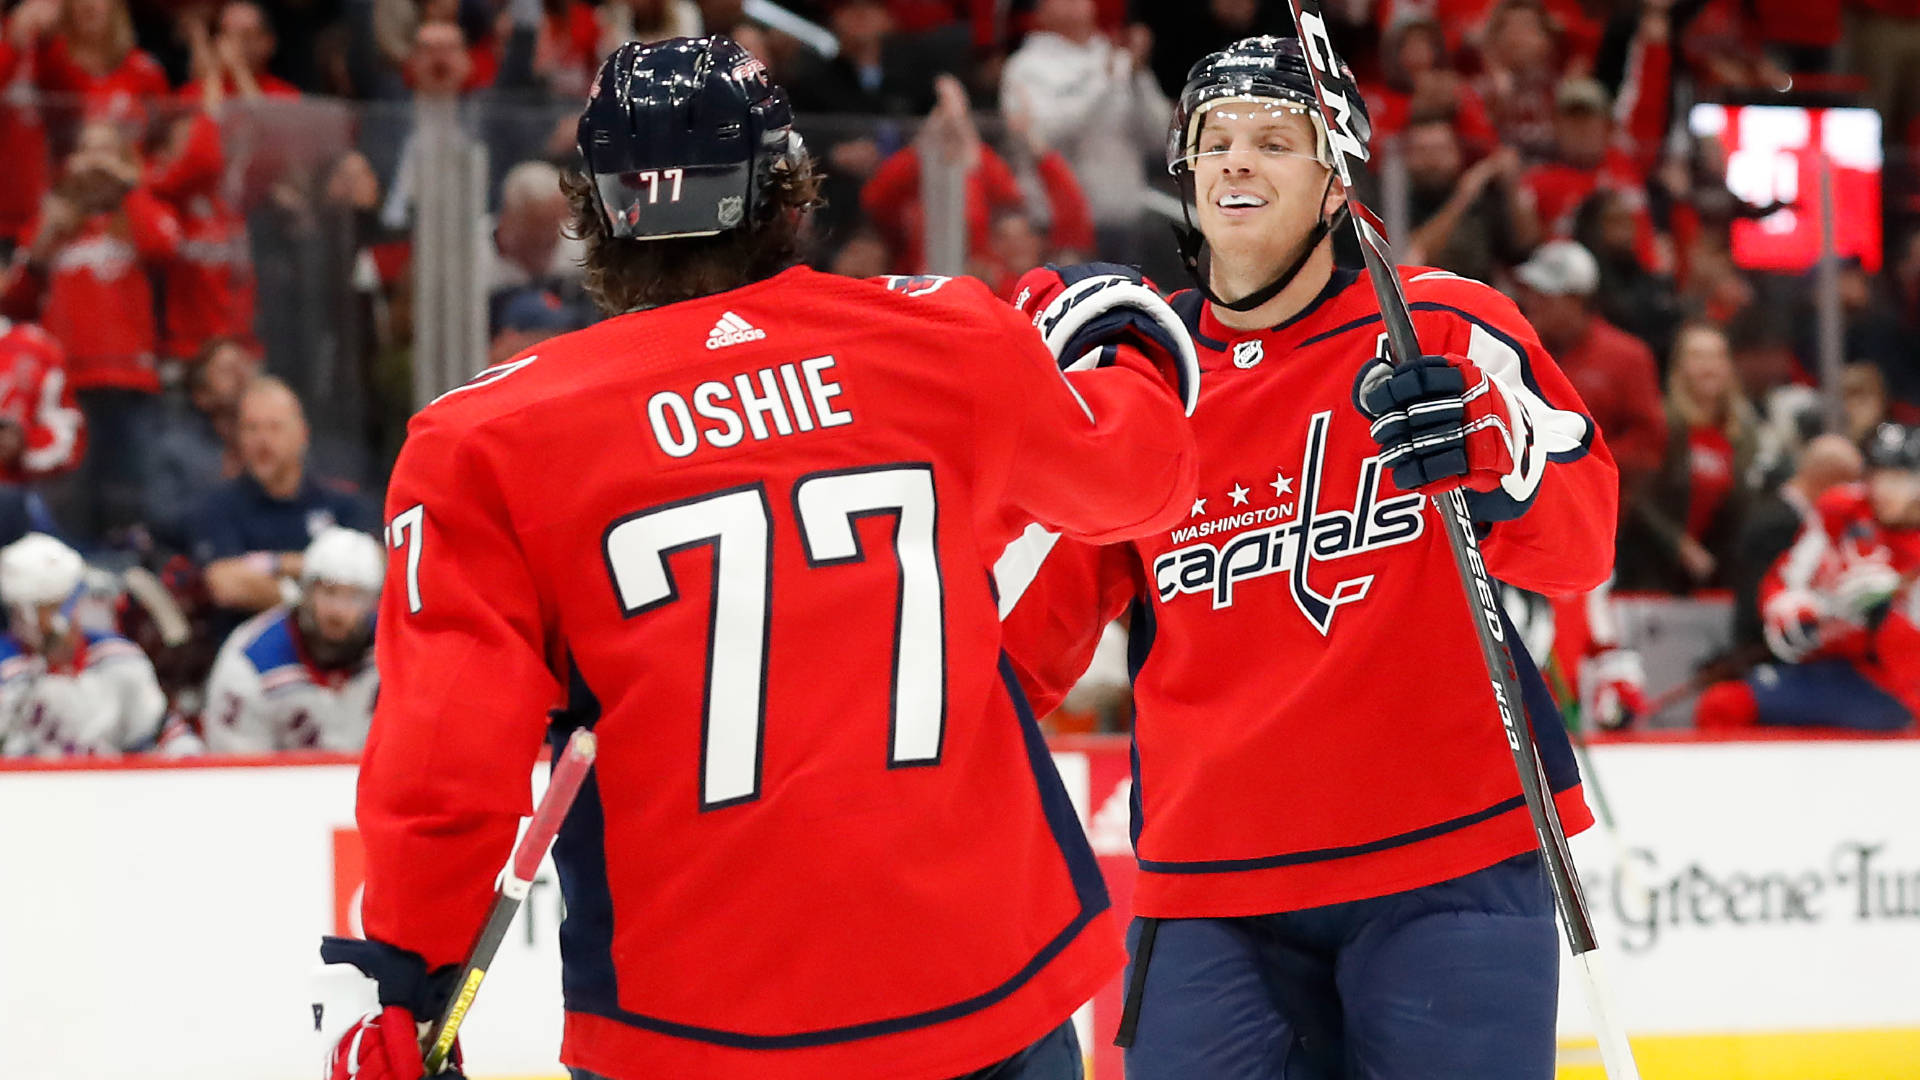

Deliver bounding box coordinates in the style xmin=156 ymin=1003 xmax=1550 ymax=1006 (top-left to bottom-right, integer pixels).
xmin=1761 ymin=484 xmax=1920 ymax=715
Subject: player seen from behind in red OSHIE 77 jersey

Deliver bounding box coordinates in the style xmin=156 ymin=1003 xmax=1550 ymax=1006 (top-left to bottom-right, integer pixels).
xmin=323 ymin=37 xmax=1198 ymax=1080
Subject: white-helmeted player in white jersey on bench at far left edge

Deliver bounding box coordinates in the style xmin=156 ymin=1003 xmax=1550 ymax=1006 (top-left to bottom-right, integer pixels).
xmin=0 ymin=532 xmax=167 ymax=757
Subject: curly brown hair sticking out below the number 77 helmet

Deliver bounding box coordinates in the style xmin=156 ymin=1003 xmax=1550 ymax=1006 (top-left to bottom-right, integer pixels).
xmin=561 ymin=154 xmax=820 ymax=315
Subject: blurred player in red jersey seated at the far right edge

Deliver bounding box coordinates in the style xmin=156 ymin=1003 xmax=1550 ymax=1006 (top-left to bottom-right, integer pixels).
xmin=1693 ymin=423 xmax=1920 ymax=730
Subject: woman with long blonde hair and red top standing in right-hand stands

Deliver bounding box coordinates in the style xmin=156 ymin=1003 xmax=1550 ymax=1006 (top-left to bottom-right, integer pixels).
xmin=1617 ymin=323 xmax=1759 ymax=594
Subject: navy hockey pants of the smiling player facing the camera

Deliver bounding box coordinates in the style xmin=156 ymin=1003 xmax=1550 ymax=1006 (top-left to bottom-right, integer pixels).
xmin=1127 ymin=853 xmax=1561 ymax=1080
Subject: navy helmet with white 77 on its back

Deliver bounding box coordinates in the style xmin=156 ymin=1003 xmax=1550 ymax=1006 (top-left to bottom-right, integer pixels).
xmin=578 ymin=37 xmax=801 ymax=240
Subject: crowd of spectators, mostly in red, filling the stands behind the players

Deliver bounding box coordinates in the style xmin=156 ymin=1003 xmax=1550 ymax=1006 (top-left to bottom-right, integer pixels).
xmin=0 ymin=0 xmax=1920 ymax=745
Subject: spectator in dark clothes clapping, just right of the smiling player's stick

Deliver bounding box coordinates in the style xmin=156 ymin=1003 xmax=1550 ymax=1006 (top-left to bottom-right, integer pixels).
xmin=1402 ymin=113 xmax=1540 ymax=281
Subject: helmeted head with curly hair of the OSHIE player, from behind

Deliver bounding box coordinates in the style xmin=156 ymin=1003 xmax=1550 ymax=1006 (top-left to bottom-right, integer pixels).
xmin=561 ymin=37 xmax=820 ymax=315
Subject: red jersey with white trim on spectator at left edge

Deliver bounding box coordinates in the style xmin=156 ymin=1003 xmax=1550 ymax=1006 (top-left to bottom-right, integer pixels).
xmin=0 ymin=311 xmax=86 ymax=484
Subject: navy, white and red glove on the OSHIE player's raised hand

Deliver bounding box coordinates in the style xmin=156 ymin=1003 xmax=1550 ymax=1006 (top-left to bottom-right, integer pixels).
xmin=1014 ymin=263 xmax=1200 ymax=415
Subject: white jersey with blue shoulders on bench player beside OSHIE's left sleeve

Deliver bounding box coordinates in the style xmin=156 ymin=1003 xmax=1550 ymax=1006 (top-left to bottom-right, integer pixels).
xmin=202 ymin=607 xmax=380 ymax=753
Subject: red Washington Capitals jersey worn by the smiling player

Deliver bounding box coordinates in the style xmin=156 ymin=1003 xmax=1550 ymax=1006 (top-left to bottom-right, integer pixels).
xmin=1000 ymin=267 xmax=1619 ymax=919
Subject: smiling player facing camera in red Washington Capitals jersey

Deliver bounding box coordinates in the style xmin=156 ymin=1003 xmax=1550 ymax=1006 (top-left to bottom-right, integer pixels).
xmin=1002 ymin=38 xmax=1617 ymax=1080
